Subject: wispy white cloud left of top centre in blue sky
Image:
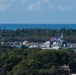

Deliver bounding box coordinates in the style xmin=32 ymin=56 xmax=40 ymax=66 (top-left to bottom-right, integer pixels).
xmin=27 ymin=1 xmax=41 ymax=11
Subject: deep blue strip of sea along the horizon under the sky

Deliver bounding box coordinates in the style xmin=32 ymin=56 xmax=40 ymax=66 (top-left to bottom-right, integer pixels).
xmin=0 ymin=24 xmax=76 ymax=30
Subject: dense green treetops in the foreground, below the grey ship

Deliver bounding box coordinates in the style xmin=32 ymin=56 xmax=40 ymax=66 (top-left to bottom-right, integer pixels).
xmin=0 ymin=46 xmax=76 ymax=75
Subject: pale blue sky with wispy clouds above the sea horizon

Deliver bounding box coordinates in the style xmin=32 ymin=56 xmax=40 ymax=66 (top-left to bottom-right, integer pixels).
xmin=0 ymin=0 xmax=76 ymax=24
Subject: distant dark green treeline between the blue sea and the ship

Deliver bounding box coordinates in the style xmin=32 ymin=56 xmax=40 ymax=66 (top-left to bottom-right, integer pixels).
xmin=0 ymin=28 xmax=76 ymax=42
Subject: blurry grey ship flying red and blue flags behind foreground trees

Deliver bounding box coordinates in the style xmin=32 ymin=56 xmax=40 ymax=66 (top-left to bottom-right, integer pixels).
xmin=41 ymin=35 xmax=76 ymax=50
